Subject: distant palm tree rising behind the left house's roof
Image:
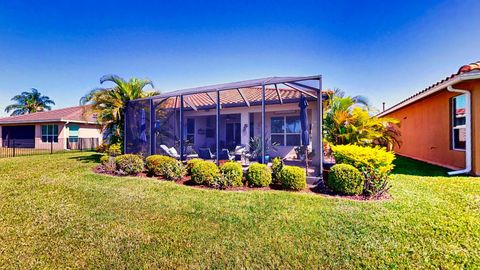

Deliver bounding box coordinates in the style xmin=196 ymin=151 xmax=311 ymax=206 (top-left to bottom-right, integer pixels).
xmin=5 ymin=88 xmax=55 ymax=116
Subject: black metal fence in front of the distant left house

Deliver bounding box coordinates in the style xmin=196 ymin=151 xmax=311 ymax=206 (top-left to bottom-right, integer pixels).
xmin=0 ymin=137 xmax=100 ymax=158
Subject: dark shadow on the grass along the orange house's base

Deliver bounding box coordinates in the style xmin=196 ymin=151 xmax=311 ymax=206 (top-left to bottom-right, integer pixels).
xmin=392 ymin=156 xmax=448 ymax=176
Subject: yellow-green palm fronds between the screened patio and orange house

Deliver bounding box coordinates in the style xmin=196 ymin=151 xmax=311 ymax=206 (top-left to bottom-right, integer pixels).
xmin=324 ymin=90 xmax=400 ymax=149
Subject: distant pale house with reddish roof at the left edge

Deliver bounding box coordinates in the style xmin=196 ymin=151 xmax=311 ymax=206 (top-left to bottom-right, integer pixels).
xmin=0 ymin=106 xmax=102 ymax=150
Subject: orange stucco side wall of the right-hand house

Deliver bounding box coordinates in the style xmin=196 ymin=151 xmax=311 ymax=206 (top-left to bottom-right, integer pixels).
xmin=387 ymin=86 xmax=470 ymax=169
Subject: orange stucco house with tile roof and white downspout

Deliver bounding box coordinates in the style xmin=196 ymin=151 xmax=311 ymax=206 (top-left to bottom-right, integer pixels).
xmin=379 ymin=62 xmax=480 ymax=175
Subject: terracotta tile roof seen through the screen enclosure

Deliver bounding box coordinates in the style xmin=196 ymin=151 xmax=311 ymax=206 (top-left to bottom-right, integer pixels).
xmin=158 ymin=87 xmax=316 ymax=109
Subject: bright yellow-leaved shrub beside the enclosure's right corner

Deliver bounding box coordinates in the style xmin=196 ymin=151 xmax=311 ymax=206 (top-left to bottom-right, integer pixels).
xmin=332 ymin=145 xmax=395 ymax=174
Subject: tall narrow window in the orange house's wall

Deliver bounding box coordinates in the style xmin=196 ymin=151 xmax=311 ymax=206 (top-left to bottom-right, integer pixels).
xmin=452 ymin=95 xmax=467 ymax=150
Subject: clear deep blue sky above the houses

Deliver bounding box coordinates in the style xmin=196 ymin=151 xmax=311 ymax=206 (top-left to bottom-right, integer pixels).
xmin=0 ymin=0 xmax=480 ymax=116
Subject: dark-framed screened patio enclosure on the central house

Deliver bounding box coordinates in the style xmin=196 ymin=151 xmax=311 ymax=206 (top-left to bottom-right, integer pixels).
xmin=126 ymin=76 xmax=322 ymax=172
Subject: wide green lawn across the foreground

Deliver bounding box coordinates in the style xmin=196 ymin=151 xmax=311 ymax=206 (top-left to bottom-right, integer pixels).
xmin=0 ymin=153 xmax=480 ymax=269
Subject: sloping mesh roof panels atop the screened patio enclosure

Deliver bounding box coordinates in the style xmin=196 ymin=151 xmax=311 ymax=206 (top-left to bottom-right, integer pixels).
xmin=142 ymin=75 xmax=321 ymax=99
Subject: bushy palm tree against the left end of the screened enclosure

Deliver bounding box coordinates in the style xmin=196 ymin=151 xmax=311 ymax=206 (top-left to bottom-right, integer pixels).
xmin=80 ymin=75 xmax=159 ymax=149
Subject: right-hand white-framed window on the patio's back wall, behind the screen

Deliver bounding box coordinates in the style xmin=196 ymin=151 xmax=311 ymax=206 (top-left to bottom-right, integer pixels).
xmin=270 ymin=116 xmax=302 ymax=146
